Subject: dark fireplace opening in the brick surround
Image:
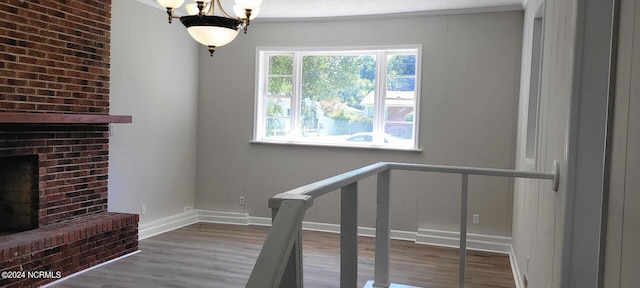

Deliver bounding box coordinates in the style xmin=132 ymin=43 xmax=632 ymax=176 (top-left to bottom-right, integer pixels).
xmin=0 ymin=155 xmax=39 ymax=236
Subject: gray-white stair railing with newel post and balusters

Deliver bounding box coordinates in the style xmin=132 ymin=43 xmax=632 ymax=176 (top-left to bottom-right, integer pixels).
xmin=246 ymin=161 xmax=560 ymax=288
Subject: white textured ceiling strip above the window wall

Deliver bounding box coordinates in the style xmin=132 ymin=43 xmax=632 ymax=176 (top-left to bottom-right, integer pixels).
xmin=138 ymin=0 xmax=527 ymax=19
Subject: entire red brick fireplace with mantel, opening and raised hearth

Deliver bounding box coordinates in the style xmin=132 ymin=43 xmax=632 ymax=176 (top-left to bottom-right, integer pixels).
xmin=0 ymin=0 xmax=138 ymax=287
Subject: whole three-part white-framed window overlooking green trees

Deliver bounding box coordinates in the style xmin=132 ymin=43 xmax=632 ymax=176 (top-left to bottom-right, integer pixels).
xmin=254 ymin=46 xmax=420 ymax=149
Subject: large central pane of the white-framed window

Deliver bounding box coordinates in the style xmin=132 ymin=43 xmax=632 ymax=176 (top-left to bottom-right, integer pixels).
xmin=301 ymin=55 xmax=375 ymax=143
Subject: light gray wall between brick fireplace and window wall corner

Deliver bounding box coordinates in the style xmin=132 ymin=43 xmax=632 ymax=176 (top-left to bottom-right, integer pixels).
xmin=109 ymin=0 xmax=198 ymax=223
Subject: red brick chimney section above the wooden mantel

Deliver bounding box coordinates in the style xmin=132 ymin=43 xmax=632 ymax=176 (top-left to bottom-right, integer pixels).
xmin=0 ymin=0 xmax=111 ymax=114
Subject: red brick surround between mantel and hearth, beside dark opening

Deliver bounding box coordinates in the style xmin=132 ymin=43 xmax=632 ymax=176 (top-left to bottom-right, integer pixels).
xmin=0 ymin=124 xmax=109 ymax=227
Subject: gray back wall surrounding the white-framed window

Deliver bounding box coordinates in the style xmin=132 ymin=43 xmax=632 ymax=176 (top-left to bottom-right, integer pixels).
xmin=196 ymin=11 xmax=523 ymax=236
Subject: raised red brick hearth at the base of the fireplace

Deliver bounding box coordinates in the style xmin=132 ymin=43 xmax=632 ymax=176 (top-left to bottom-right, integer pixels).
xmin=0 ymin=212 xmax=138 ymax=288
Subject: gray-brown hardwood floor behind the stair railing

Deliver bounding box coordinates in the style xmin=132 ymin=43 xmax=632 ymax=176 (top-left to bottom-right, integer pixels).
xmin=48 ymin=223 xmax=515 ymax=288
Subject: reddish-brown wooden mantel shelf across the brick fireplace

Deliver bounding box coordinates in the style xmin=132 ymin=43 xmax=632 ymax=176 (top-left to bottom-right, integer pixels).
xmin=0 ymin=112 xmax=132 ymax=124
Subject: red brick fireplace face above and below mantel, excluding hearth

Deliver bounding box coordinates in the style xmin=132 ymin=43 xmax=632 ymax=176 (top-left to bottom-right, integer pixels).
xmin=0 ymin=0 xmax=111 ymax=226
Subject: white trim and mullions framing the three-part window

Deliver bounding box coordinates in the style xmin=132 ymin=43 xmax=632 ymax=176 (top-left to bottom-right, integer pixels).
xmin=250 ymin=44 xmax=423 ymax=152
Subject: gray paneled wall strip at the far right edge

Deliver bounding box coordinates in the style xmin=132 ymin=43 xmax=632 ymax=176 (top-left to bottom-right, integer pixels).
xmin=604 ymin=0 xmax=640 ymax=288
